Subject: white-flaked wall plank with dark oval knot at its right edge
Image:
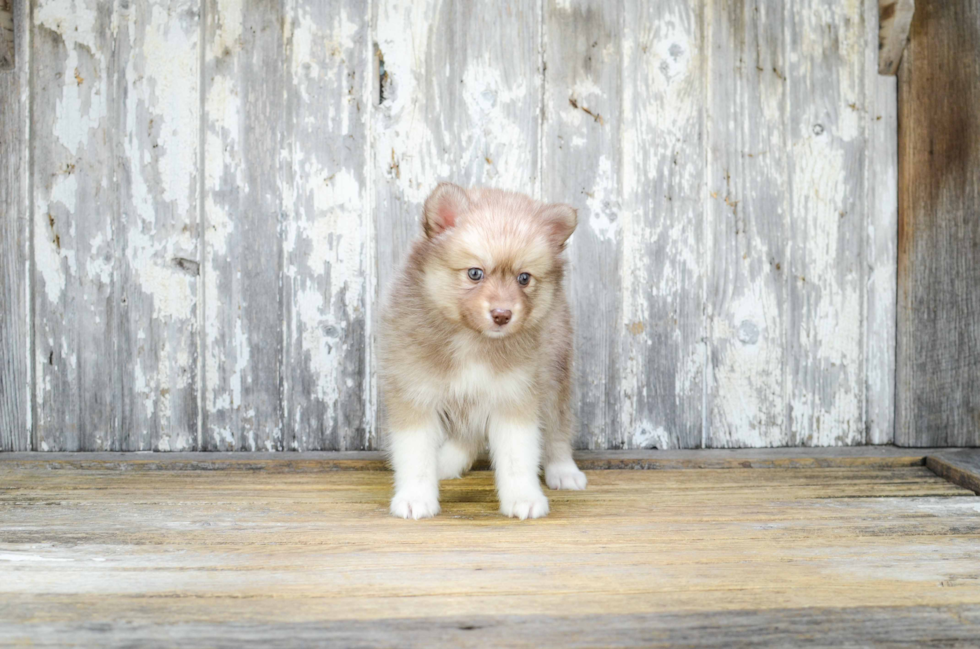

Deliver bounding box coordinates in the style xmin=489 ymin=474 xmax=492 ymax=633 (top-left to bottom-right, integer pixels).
xmin=112 ymin=0 xmax=201 ymax=451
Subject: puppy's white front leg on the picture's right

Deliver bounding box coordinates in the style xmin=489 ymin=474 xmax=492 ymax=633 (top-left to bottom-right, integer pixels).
xmin=489 ymin=411 xmax=548 ymax=520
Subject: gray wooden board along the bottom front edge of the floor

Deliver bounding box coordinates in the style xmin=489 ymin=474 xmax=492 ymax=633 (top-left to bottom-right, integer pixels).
xmin=0 ymin=602 xmax=980 ymax=649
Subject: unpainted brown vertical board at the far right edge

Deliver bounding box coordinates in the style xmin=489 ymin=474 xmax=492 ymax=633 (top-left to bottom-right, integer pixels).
xmin=895 ymin=0 xmax=980 ymax=446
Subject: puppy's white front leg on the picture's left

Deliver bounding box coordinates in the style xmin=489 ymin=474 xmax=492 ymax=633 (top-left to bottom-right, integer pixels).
xmin=388 ymin=403 xmax=443 ymax=520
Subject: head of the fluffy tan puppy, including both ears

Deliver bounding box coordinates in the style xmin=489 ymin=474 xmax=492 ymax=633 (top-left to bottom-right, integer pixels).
xmin=422 ymin=183 xmax=577 ymax=338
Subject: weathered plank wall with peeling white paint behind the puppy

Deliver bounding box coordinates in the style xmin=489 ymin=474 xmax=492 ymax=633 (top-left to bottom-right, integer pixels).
xmin=0 ymin=0 xmax=897 ymax=450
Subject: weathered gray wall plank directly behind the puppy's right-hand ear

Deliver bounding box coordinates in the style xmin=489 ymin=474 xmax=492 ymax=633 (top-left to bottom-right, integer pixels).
xmin=541 ymin=0 xmax=630 ymax=448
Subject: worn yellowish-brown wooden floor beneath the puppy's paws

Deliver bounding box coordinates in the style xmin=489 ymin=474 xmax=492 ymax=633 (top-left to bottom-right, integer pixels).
xmin=0 ymin=454 xmax=980 ymax=647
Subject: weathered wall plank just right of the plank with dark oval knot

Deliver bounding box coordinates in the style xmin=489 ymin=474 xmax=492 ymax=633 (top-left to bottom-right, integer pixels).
xmin=202 ymin=0 xmax=284 ymax=451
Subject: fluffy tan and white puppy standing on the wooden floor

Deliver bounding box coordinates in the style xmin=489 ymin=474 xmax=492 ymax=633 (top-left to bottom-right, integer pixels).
xmin=379 ymin=183 xmax=586 ymax=519
